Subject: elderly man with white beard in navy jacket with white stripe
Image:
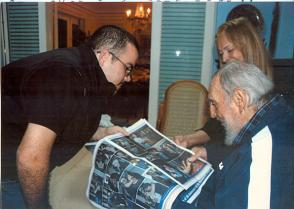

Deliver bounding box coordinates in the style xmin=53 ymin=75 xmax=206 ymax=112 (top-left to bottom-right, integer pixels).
xmin=173 ymin=61 xmax=294 ymax=209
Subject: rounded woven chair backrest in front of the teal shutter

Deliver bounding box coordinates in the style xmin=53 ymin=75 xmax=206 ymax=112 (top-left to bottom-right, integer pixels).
xmin=157 ymin=80 xmax=207 ymax=137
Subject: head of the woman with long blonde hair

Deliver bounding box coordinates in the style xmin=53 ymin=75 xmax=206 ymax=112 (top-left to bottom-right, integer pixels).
xmin=215 ymin=17 xmax=273 ymax=79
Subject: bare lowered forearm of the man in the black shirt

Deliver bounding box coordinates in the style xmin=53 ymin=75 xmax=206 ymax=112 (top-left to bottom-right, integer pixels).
xmin=17 ymin=123 xmax=56 ymax=209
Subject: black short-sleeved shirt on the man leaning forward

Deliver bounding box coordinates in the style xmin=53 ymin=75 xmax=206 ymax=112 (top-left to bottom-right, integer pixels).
xmin=1 ymin=46 xmax=115 ymax=180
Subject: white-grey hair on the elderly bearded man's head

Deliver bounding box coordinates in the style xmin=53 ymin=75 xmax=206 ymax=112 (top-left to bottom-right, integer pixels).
xmin=216 ymin=60 xmax=274 ymax=109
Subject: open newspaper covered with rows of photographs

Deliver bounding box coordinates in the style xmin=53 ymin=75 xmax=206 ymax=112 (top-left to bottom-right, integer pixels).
xmin=85 ymin=119 xmax=213 ymax=209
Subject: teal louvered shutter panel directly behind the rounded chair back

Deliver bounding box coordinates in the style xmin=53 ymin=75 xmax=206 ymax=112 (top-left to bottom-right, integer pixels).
xmin=159 ymin=2 xmax=206 ymax=101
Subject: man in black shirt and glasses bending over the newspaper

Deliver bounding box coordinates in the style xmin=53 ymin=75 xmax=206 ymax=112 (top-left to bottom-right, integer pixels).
xmin=1 ymin=25 xmax=138 ymax=209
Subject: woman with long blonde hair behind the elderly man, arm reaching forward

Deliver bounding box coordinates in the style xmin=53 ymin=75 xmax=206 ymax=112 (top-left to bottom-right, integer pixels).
xmin=175 ymin=17 xmax=273 ymax=164
